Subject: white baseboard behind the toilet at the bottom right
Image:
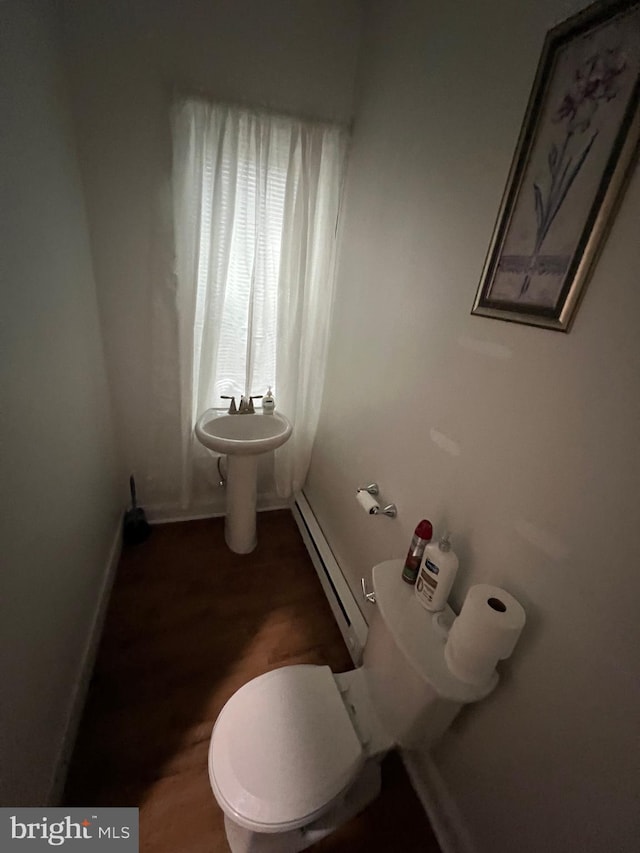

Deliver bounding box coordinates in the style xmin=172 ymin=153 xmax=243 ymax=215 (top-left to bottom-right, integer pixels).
xmin=400 ymin=750 xmax=477 ymax=853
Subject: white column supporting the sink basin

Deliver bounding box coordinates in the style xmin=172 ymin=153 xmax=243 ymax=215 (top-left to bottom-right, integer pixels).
xmin=224 ymin=454 xmax=259 ymax=554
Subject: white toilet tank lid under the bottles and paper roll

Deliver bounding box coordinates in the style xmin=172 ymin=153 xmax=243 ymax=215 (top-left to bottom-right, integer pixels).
xmin=372 ymin=560 xmax=498 ymax=704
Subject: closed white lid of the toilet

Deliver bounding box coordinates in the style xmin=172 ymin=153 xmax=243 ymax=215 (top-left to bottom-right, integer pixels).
xmin=209 ymin=664 xmax=364 ymax=832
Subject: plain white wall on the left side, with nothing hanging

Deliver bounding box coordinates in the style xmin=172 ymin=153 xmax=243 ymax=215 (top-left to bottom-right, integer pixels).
xmin=0 ymin=0 xmax=122 ymax=805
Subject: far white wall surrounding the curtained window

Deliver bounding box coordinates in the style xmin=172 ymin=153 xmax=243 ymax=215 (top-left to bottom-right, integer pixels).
xmin=63 ymin=0 xmax=361 ymax=515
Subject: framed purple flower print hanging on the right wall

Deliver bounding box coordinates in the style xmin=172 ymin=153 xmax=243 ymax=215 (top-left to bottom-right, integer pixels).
xmin=471 ymin=0 xmax=640 ymax=332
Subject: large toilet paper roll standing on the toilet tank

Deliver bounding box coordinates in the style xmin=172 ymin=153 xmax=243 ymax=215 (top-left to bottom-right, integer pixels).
xmin=444 ymin=583 xmax=526 ymax=685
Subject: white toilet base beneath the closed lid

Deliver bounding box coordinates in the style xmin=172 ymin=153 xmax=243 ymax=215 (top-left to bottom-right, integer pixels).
xmin=224 ymin=760 xmax=380 ymax=853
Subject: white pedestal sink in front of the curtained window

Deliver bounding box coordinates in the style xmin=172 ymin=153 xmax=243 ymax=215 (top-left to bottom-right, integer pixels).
xmin=196 ymin=409 xmax=291 ymax=554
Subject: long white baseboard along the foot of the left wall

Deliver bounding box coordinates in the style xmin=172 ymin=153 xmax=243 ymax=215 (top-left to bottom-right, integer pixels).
xmin=46 ymin=519 xmax=122 ymax=806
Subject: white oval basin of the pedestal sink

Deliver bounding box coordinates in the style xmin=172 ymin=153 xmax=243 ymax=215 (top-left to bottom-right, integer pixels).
xmin=196 ymin=409 xmax=291 ymax=456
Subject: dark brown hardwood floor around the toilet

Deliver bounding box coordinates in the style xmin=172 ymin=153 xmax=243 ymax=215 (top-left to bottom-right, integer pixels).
xmin=65 ymin=511 xmax=439 ymax=853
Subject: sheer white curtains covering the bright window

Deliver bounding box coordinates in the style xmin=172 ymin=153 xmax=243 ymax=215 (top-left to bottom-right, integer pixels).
xmin=173 ymin=98 xmax=347 ymax=506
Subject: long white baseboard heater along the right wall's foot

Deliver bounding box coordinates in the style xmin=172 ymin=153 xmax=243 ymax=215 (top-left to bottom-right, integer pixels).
xmin=292 ymin=492 xmax=368 ymax=666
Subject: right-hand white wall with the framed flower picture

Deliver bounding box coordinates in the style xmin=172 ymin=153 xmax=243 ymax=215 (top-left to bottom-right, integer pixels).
xmin=306 ymin=0 xmax=640 ymax=853
